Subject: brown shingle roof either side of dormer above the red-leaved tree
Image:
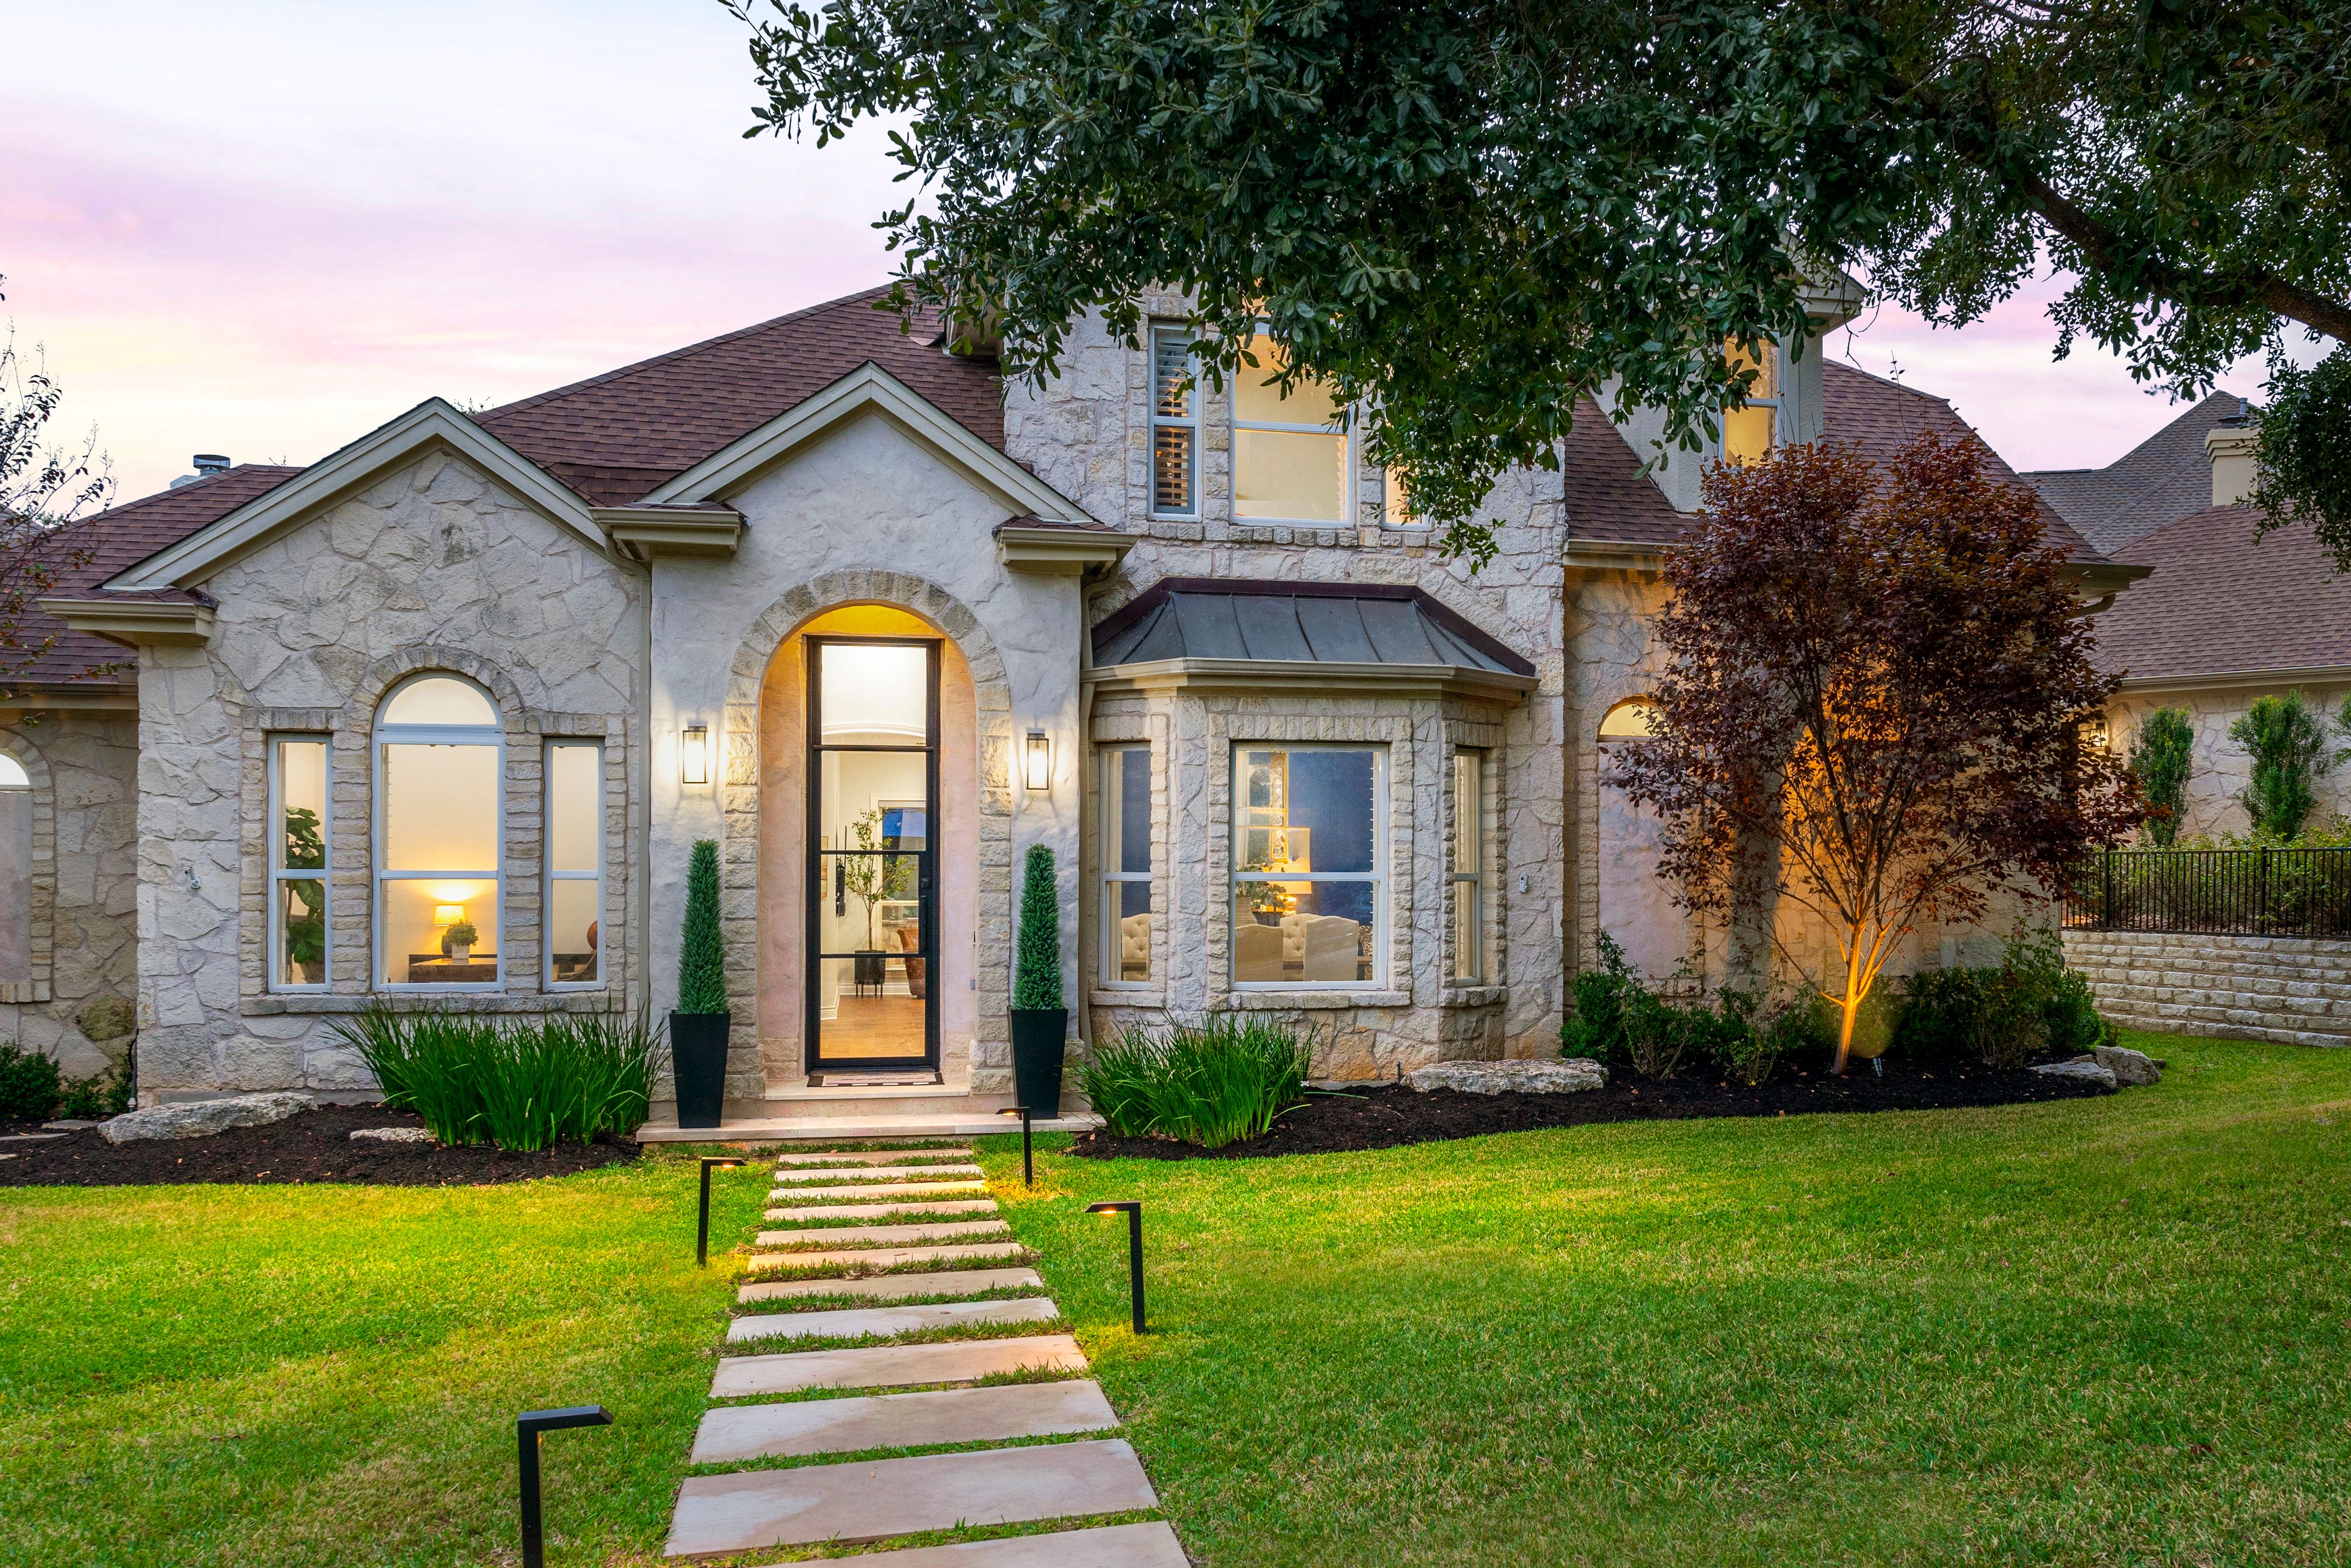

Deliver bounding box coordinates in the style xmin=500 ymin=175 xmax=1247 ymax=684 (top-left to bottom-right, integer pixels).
xmin=1561 ymin=360 xmax=2104 ymax=562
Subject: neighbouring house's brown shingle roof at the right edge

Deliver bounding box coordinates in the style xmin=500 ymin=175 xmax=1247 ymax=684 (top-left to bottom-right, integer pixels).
xmin=2097 ymin=505 xmax=2351 ymax=682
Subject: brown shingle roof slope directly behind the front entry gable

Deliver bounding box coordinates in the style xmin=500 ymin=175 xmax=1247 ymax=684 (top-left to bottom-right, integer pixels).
xmin=477 ymin=289 xmax=1004 ymax=505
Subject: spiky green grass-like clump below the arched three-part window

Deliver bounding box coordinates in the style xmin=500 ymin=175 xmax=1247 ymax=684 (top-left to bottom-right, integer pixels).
xmin=334 ymin=1002 xmax=663 ymax=1154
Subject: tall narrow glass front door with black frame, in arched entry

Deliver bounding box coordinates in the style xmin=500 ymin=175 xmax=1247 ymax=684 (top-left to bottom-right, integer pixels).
xmin=804 ymin=637 xmax=938 ymax=1070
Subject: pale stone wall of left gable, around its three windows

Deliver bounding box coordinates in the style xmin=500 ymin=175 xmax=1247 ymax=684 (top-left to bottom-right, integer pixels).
xmin=139 ymin=454 xmax=644 ymax=1103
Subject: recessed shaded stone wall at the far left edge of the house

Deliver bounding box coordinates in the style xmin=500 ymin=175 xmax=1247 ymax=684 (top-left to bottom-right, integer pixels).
xmin=0 ymin=710 xmax=139 ymax=1077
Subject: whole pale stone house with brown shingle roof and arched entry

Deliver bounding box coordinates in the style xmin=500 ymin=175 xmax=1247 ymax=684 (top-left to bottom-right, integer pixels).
xmin=18 ymin=291 xmax=2144 ymax=1114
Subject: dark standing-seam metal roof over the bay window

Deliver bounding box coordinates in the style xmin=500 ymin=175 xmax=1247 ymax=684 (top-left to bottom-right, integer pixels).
xmin=1093 ymin=578 xmax=1535 ymax=677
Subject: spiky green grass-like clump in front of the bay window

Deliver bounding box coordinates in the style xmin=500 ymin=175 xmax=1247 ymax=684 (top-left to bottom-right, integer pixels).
xmin=1077 ymin=1013 xmax=1314 ymax=1150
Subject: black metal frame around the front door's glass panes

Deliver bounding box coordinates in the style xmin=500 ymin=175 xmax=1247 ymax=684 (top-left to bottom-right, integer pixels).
xmin=799 ymin=635 xmax=945 ymax=1075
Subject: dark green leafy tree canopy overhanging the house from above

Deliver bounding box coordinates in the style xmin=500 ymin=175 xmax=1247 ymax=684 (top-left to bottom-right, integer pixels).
xmin=727 ymin=0 xmax=2351 ymax=555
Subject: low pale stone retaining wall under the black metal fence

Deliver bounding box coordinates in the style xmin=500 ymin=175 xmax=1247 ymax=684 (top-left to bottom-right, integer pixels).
xmin=2064 ymin=931 xmax=2351 ymax=1046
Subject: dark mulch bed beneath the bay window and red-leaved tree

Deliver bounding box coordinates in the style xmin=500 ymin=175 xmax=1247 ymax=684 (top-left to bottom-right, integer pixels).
xmin=1070 ymin=1058 xmax=2116 ymax=1159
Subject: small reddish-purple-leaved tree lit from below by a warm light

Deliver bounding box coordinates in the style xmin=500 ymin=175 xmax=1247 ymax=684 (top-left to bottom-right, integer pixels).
xmin=1606 ymin=435 xmax=2139 ymax=1070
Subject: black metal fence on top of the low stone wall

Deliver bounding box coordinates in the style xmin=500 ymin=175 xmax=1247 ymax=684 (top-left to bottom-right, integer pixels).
xmin=2064 ymin=849 xmax=2351 ymax=935
